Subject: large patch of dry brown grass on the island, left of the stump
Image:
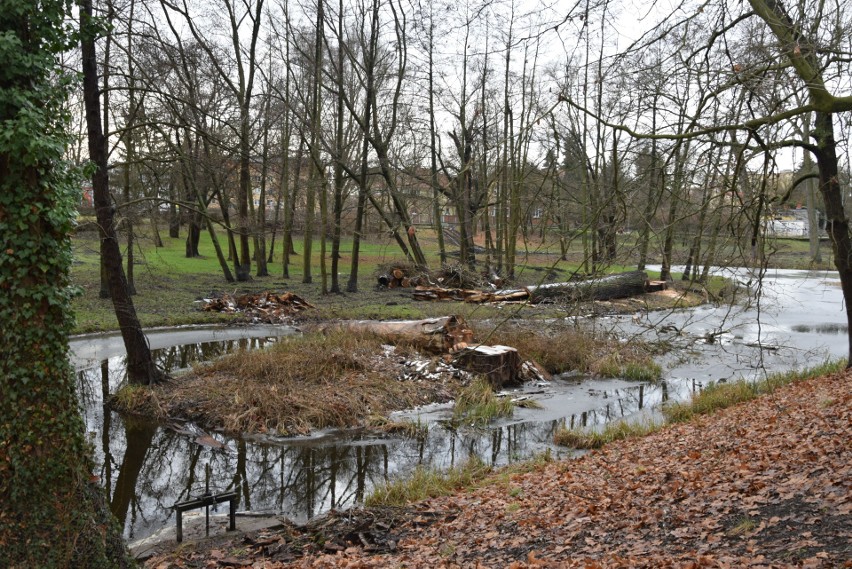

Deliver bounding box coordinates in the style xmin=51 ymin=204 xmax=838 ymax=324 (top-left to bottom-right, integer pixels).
xmin=119 ymin=331 xmax=460 ymax=435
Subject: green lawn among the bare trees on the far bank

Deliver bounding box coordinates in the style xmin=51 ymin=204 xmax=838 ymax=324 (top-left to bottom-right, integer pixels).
xmin=72 ymin=222 xmax=744 ymax=336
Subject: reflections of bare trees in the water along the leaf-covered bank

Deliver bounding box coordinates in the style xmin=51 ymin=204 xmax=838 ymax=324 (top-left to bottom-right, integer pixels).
xmin=101 ymin=382 xmax=704 ymax=536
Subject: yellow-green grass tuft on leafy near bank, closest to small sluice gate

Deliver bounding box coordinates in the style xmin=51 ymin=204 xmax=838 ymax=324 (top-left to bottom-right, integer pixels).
xmin=364 ymin=456 xmax=492 ymax=507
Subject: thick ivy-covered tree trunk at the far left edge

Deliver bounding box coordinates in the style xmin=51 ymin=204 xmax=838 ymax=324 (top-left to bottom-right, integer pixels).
xmin=0 ymin=0 xmax=129 ymax=567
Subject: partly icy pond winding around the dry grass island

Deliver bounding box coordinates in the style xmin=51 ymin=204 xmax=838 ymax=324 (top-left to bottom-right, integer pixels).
xmin=71 ymin=271 xmax=848 ymax=541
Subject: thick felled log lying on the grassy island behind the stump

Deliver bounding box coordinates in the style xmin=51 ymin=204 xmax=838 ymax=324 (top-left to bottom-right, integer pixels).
xmin=323 ymin=316 xmax=473 ymax=354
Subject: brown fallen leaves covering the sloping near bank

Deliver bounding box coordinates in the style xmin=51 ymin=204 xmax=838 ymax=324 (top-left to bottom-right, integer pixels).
xmin=146 ymin=366 xmax=852 ymax=569
